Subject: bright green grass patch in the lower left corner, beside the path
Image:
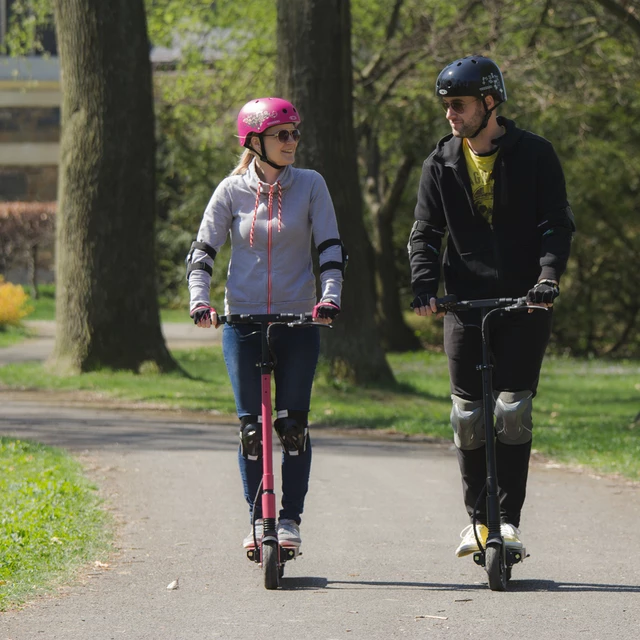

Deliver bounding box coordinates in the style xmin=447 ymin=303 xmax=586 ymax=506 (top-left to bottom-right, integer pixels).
xmin=0 ymin=437 xmax=111 ymax=611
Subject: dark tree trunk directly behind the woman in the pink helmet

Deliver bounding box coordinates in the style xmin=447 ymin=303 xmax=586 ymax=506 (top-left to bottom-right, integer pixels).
xmin=277 ymin=0 xmax=393 ymax=384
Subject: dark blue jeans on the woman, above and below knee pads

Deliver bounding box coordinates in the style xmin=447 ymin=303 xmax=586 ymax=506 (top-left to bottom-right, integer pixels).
xmin=222 ymin=324 xmax=320 ymax=524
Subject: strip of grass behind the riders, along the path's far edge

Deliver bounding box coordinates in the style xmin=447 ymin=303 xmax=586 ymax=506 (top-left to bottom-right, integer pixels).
xmin=0 ymin=347 xmax=640 ymax=480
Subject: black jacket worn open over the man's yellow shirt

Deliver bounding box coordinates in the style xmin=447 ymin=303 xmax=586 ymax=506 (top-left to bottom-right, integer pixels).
xmin=408 ymin=117 xmax=575 ymax=300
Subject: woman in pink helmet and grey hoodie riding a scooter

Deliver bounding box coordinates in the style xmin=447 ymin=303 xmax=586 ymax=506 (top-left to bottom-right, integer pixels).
xmin=187 ymin=98 xmax=346 ymax=548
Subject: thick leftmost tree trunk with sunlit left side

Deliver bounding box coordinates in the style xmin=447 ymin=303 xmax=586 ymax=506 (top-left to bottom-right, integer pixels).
xmin=52 ymin=0 xmax=177 ymax=372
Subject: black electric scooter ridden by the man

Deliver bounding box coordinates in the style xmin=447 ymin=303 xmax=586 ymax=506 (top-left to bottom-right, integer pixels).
xmin=436 ymin=295 xmax=546 ymax=591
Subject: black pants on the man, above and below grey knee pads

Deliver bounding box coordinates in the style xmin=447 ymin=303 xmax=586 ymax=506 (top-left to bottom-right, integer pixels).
xmin=444 ymin=311 xmax=553 ymax=527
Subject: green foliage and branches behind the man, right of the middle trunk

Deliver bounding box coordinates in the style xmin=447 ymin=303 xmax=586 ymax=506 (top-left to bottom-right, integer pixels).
xmin=352 ymin=0 xmax=640 ymax=357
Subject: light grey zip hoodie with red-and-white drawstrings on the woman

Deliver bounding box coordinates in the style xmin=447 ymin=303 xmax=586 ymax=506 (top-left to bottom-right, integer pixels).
xmin=189 ymin=160 xmax=343 ymax=314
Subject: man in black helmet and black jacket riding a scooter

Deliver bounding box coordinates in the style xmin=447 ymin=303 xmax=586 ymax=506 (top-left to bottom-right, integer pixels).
xmin=408 ymin=56 xmax=575 ymax=557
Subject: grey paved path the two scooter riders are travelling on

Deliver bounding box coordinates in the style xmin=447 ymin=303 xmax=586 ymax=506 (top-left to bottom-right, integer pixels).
xmin=0 ymin=330 xmax=640 ymax=640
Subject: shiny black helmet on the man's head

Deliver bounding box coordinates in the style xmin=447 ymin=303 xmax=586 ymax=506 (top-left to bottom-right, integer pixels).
xmin=436 ymin=56 xmax=507 ymax=104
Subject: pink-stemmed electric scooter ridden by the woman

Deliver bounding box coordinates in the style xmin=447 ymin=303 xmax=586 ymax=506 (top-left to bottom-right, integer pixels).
xmin=218 ymin=313 xmax=331 ymax=589
